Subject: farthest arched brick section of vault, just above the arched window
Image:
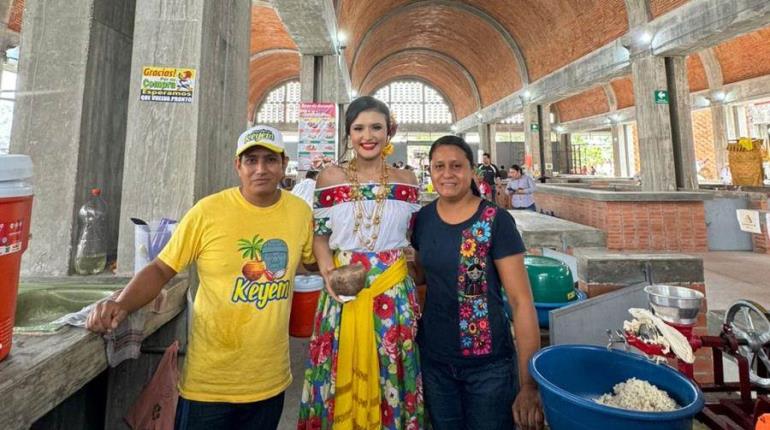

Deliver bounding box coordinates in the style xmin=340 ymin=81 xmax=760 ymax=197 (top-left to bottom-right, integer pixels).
xmin=359 ymin=51 xmax=480 ymax=119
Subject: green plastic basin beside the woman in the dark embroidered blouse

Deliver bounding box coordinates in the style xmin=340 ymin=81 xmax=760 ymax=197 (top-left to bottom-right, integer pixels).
xmin=524 ymin=255 xmax=577 ymax=303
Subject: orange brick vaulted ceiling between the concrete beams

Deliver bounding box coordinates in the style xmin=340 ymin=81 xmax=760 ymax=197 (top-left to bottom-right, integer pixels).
xmin=6 ymin=0 xmax=770 ymax=121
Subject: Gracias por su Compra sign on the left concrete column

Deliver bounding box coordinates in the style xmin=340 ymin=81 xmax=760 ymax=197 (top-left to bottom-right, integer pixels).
xmin=139 ymin=66 xmax=197 ymax=103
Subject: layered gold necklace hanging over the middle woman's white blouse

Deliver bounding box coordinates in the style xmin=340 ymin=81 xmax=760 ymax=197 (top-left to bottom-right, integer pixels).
xmin=346 ymin=158 xmax=389 ymax=251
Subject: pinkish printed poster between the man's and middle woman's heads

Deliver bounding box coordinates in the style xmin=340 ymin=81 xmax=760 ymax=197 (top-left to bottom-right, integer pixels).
xmin=297 ymin=103 xmax=337 ymax=170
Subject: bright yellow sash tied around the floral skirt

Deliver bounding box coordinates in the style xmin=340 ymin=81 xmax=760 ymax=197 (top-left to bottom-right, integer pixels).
xmin=334 ymin=257 xmax=408 ymax=430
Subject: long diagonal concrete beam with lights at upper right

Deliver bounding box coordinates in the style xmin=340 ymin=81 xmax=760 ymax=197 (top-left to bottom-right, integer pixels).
xmin=454 ymin=0 xmax=770 ymax=132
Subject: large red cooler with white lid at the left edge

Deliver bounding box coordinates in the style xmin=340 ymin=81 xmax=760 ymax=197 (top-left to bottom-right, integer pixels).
xmin=0 ymin=155 xmax=32 ymax=360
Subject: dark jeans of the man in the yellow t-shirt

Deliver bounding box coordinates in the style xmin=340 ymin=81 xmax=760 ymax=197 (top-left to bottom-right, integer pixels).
xmin=174 ymin=393 xmax=284 ymax=430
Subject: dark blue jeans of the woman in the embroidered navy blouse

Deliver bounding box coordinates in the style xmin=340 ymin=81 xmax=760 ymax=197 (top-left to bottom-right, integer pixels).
xmin=421 ymin=356 xmax=519 ymax=430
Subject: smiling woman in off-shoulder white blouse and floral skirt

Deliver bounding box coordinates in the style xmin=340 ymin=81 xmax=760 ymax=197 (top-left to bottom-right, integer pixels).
xmin=298 ymin=97 xmax=423 ymax=430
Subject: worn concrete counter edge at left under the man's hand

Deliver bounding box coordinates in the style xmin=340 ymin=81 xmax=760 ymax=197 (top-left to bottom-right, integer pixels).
xmin=0 ymin=276 xmax=189 ymax=430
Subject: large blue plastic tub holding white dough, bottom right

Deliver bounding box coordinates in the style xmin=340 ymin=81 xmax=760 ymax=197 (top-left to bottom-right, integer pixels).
xmin=529 ymin=345 xmax=703 ymax=430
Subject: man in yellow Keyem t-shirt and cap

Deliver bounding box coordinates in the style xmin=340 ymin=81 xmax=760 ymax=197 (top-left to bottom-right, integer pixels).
xmin=87 ymin=126 xmax=315 ymax=429
